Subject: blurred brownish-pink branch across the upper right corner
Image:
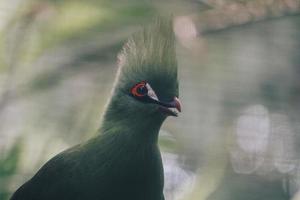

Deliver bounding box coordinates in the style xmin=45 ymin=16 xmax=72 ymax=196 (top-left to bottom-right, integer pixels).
xmin=191 ymin=0 xmax=300 ymax=32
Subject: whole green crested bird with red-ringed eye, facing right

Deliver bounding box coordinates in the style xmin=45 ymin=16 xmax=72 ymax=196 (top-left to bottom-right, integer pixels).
xmin=11 ymin=19 xmax=181 ymax=200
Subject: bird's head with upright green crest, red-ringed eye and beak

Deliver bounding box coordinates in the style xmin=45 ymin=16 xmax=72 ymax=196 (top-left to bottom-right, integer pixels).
xmin=104 ymin=19 xmax=181 ymax=127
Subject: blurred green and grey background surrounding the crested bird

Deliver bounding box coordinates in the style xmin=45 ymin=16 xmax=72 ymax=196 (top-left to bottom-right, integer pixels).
xmin=0 ymin=0 xmax=300 ymax=200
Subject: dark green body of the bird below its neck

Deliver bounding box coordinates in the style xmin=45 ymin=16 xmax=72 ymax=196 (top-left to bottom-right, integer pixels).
xmin=13 ymin=129 xmax=163 ymax=200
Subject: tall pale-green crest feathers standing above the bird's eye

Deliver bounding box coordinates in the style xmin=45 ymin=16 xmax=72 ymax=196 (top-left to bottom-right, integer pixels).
xmin=117 ymin=18 xmax=177 ymax=97
